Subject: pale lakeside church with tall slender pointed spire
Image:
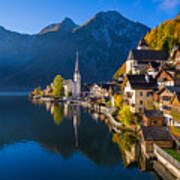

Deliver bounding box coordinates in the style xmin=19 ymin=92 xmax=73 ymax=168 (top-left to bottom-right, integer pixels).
xmin=63 ymin=51 xmax=81 ymax=99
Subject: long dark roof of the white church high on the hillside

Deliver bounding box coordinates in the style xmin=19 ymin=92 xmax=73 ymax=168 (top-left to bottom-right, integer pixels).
xmin=128 ymin=49 xmax=168 ymax=61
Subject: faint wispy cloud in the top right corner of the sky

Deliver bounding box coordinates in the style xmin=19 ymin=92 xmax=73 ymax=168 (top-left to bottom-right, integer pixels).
xmin=153 ymin=0 xmax=180 ymax=10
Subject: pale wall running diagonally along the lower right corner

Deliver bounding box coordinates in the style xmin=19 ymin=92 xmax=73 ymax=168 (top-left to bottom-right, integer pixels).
xmin=153 ymin=144 xmax=180 ymax=170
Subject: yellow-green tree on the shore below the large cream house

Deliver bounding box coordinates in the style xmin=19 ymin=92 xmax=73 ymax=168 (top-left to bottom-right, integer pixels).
xmin=119 ymin=105 xmax=135 ymax=126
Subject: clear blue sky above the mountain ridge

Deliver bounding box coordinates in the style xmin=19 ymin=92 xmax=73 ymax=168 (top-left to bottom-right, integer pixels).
xmin=0 ymin=0 xmax=180 ymax=34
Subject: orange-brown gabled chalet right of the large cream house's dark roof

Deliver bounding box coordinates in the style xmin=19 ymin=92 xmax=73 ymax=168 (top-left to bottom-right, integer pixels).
xmin=156 ymin=68 xmax=180 ymax=86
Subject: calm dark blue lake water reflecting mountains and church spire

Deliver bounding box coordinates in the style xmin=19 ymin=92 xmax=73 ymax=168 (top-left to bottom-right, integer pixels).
xmin=0 ymin=93 xmax=156 ymax=180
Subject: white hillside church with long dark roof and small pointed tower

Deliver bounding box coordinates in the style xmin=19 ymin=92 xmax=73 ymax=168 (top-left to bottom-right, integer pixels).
xmin=126 ymin=39 xmax=168 ymax=74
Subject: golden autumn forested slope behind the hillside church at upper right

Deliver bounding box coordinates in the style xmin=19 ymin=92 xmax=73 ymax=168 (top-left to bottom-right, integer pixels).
xmin=145 ymin=13 xmax=180 ymax=52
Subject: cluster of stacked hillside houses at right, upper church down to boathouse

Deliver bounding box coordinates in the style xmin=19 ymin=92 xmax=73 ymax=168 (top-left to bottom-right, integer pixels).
xmin=123 ymin=39 xmax=180 ymax=153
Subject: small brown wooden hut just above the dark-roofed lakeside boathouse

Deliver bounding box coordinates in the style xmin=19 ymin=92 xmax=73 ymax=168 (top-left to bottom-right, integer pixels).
xmin=143 ymin=110 xmax=164 ymax=127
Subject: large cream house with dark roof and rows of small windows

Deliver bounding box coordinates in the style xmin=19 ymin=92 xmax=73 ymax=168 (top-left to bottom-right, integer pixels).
xmin=124 ymin=75 xmax=156 ymax=113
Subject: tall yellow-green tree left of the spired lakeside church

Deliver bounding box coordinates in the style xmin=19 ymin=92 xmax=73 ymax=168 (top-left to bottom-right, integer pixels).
xmin=53 ymin=75 xmax=64 ymax=98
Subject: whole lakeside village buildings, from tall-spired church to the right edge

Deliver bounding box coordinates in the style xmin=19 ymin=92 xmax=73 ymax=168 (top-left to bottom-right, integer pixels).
xmin=29 ymin=39 xmax=180 ymax=177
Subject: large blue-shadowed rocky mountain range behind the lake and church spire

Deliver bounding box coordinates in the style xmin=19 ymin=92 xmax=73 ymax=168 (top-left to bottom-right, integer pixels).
xmin=0 ymin=11 xmax=150 ymax=87
